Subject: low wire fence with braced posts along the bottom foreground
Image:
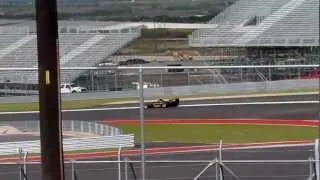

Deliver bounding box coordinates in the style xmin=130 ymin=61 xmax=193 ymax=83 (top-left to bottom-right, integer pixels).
xmin=0 ymin=140 xmax=319 ymax=180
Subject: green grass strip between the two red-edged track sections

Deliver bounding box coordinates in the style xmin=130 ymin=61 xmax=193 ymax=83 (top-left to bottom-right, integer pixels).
xmin=117 ymin=124 xmax=318 ymax=143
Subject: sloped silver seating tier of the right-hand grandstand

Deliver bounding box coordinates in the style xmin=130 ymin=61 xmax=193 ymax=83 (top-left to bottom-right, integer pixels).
xmin=189 ymin=0 xmax=319 ymax=47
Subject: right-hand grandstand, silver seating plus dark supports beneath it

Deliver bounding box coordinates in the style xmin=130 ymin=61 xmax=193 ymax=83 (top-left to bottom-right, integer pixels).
xmin=189 ymin=0 xmax=320 ymax=80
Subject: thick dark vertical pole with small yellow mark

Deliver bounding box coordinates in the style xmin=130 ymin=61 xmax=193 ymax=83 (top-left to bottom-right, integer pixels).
xmin=36 ymin=0 xmax=64 ymax=180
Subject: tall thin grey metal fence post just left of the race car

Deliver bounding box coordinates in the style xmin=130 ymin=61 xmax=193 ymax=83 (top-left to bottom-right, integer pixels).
xmin=139 ymin=65 xmax=145 ymax=180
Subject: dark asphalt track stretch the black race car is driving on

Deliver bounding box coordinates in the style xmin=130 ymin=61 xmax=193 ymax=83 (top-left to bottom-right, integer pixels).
xmin=0 ymin=95 xmax=319 ymax=122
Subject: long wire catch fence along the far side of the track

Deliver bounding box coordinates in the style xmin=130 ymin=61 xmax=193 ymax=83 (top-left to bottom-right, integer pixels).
xmin=0 ymin=64 xmax=320 ymax=96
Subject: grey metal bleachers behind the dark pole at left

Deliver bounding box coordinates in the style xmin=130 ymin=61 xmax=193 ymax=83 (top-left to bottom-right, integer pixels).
xmin=0 ymin=21 xmax=141 ymax=84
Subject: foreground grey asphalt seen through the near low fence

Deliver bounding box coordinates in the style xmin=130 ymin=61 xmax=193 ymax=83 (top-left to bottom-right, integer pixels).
xmin=0 ymin=146 xmax=314 ymax=180
